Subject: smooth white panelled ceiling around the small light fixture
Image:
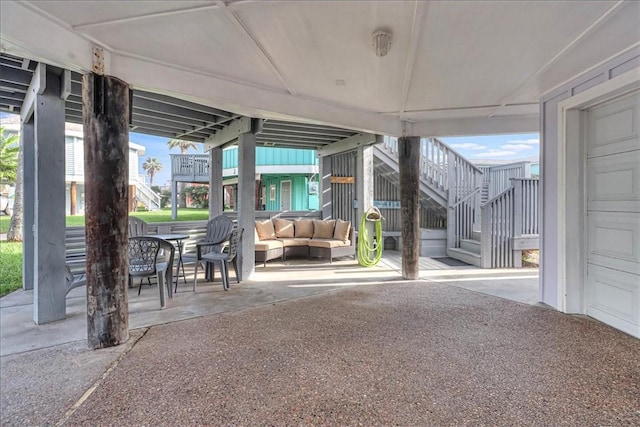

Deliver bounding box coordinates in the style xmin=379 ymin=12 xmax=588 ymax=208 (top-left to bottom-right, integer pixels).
xmin=0 ymin=0 xmax=640 ymax=136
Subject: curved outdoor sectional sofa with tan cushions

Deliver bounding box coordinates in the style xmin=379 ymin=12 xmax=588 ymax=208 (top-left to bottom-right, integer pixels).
xmin=255 ymin=218 xmax=356 ymax=267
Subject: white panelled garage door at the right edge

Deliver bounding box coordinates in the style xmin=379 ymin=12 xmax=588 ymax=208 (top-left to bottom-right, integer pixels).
xmin=586 ymin=91 xmax=640 ymax=338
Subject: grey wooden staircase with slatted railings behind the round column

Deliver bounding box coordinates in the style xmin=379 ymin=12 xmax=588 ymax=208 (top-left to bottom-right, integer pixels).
xmin=374 ymin=137 xmax=539 ymax=268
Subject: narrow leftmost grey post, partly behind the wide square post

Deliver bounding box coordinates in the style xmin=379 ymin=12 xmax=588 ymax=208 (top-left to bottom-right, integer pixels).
xmin=20 ymin=116 xmax=36 ymax=290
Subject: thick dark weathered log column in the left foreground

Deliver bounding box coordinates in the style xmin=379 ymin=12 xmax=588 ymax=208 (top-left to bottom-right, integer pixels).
xmin=82 ymin=74 xmax=129 ymax=349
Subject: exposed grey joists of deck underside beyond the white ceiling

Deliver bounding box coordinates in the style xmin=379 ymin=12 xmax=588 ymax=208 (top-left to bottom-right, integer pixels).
xmin=0 ymin=53 xmax=358 ymax=150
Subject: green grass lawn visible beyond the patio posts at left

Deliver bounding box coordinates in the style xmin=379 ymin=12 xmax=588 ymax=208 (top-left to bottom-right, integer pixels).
xmin=0 ymin=209 xmax=209 ymax=297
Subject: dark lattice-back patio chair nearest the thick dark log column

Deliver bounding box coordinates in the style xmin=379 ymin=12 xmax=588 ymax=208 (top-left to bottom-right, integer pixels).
xmin=129 ymin=236 xmax=175 ymax=308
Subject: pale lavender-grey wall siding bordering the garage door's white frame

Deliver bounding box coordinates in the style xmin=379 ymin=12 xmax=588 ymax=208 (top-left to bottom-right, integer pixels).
xmin=540 ymin=48 xmax=640 ymax=311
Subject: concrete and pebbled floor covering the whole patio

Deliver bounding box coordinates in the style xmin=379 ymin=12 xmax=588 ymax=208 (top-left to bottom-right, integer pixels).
xmin=0 ymin=253 xmax=640 ymax=425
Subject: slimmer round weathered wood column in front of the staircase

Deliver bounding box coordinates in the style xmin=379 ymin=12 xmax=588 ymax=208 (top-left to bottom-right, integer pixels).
xmin=398 ymin=136 xmax=420 ymax=280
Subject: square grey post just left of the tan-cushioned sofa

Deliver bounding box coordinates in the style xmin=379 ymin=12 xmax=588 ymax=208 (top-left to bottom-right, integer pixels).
xmin=237 ymin=133 xmax=256 ymax=280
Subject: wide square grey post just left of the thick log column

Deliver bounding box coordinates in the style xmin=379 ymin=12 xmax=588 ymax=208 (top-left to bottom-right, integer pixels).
xmin=32 ymin=69 xmax=66 ymax=324
